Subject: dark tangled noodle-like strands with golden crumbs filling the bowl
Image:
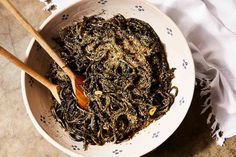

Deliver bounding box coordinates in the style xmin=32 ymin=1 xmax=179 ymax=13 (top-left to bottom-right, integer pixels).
xmin=49 ymin=14 xmax=178 ymax=149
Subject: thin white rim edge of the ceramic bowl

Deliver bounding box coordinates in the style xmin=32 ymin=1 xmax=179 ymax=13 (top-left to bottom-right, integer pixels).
xmin=21 ymin=0 xmax=195 ymax=157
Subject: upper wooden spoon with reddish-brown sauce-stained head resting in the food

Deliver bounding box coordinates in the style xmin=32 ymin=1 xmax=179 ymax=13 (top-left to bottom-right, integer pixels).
xmin=0 ymin=0 xmax=89 ymax=110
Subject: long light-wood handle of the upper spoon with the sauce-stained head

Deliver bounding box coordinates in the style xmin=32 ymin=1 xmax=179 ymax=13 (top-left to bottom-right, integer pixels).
xmin=0 ymin=0 xmax=75 ymax=78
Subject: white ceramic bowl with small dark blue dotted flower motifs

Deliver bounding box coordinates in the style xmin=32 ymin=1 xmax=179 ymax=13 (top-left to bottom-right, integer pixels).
xmin=22 ymin=0 xmax=195 ymax=157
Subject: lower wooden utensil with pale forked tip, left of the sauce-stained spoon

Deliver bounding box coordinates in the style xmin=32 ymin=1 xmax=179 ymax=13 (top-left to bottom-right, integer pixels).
xmin=0 ymin=46 xmax=61 ymax=103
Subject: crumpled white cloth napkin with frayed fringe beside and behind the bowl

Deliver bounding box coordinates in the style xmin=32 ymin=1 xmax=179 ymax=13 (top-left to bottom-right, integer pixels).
xmin=41 ymin=0 xmax=236 ymax=145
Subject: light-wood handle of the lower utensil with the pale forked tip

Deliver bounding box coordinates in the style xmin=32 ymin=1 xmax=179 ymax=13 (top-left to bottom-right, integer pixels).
xmin=0 ymin=46 xmax=56 ymax=89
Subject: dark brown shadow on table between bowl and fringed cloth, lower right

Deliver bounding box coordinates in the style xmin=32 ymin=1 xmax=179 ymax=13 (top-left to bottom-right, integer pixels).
xmin=143 ymin=83 xmax=213 ymax=157
